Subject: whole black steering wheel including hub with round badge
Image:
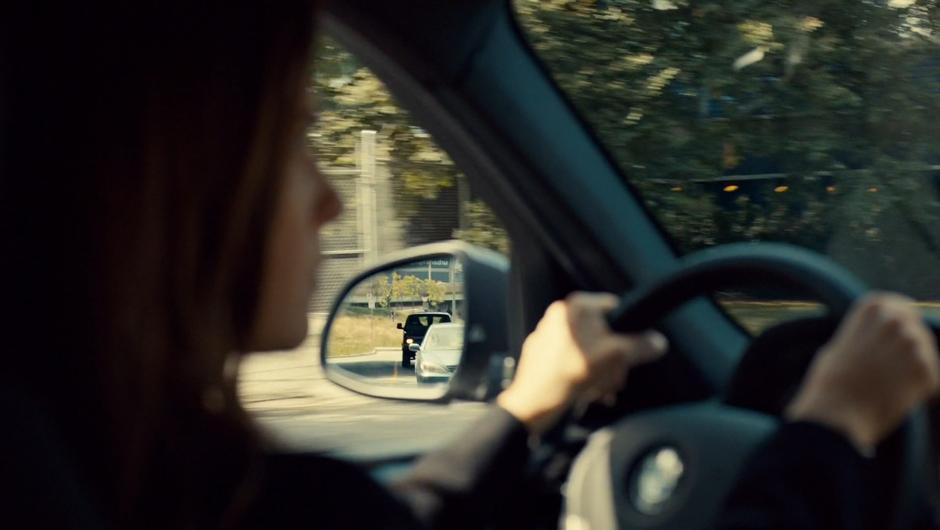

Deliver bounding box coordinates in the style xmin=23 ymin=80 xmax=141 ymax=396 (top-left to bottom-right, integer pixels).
xmin=564 ymin=243 xmax=931 ymax=530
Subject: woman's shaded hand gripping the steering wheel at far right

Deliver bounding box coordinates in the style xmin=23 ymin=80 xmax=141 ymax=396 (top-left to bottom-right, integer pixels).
xmin=787 ymin=293 xmax=940 ymax=450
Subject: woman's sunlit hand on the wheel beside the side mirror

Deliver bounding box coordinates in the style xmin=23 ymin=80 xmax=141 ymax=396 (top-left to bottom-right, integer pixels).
xmin=497 ymin=293 xmax=667 ymax=434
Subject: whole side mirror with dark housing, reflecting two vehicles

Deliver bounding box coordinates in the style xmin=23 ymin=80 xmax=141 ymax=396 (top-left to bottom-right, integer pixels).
xmin=320 ymin=241 xmax=509 ymax=401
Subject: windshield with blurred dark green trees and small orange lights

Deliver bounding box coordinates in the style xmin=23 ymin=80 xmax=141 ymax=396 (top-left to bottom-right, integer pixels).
xmin=515 ymin=0 xmax=940 ymax=330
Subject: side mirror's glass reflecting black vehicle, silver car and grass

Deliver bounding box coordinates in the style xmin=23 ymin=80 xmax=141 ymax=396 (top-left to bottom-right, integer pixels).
xmin=324 ymin=256 xmax=464 ymax=388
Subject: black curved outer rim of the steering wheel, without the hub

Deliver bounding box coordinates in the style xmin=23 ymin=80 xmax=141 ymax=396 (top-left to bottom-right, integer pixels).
xmin=560 ymin=243 xmax=929 ymax=530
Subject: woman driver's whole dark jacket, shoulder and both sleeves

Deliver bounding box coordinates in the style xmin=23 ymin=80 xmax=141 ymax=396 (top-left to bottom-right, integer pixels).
xmin=0 ymin=384 xmax=912 ymax=530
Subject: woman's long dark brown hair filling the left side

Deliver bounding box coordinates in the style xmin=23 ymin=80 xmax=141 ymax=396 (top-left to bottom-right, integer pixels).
xmin=0 ymin=0 xmax=315 ymax=528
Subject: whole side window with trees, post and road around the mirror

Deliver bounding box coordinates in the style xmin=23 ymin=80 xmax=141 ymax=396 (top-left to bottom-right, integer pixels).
xmin=239 ymin=38 xmax=509 ymax=450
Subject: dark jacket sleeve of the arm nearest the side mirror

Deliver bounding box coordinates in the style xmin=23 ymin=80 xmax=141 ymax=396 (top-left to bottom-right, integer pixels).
xmin=237 ymin=407 xmax=529 ymax=530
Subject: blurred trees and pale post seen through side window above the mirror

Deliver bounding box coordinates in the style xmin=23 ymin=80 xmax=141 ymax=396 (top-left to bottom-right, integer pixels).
xmin=309 ymin=39 xmax=509 ymax=313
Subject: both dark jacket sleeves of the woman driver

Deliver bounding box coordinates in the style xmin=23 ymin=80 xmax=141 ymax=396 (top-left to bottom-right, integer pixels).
xmin=251 ymin=418 xmax=916 ymax=530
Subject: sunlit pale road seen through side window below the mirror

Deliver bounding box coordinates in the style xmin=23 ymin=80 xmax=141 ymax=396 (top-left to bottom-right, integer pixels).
xmin=239 ymin=330 xmax=486 ymax=459
